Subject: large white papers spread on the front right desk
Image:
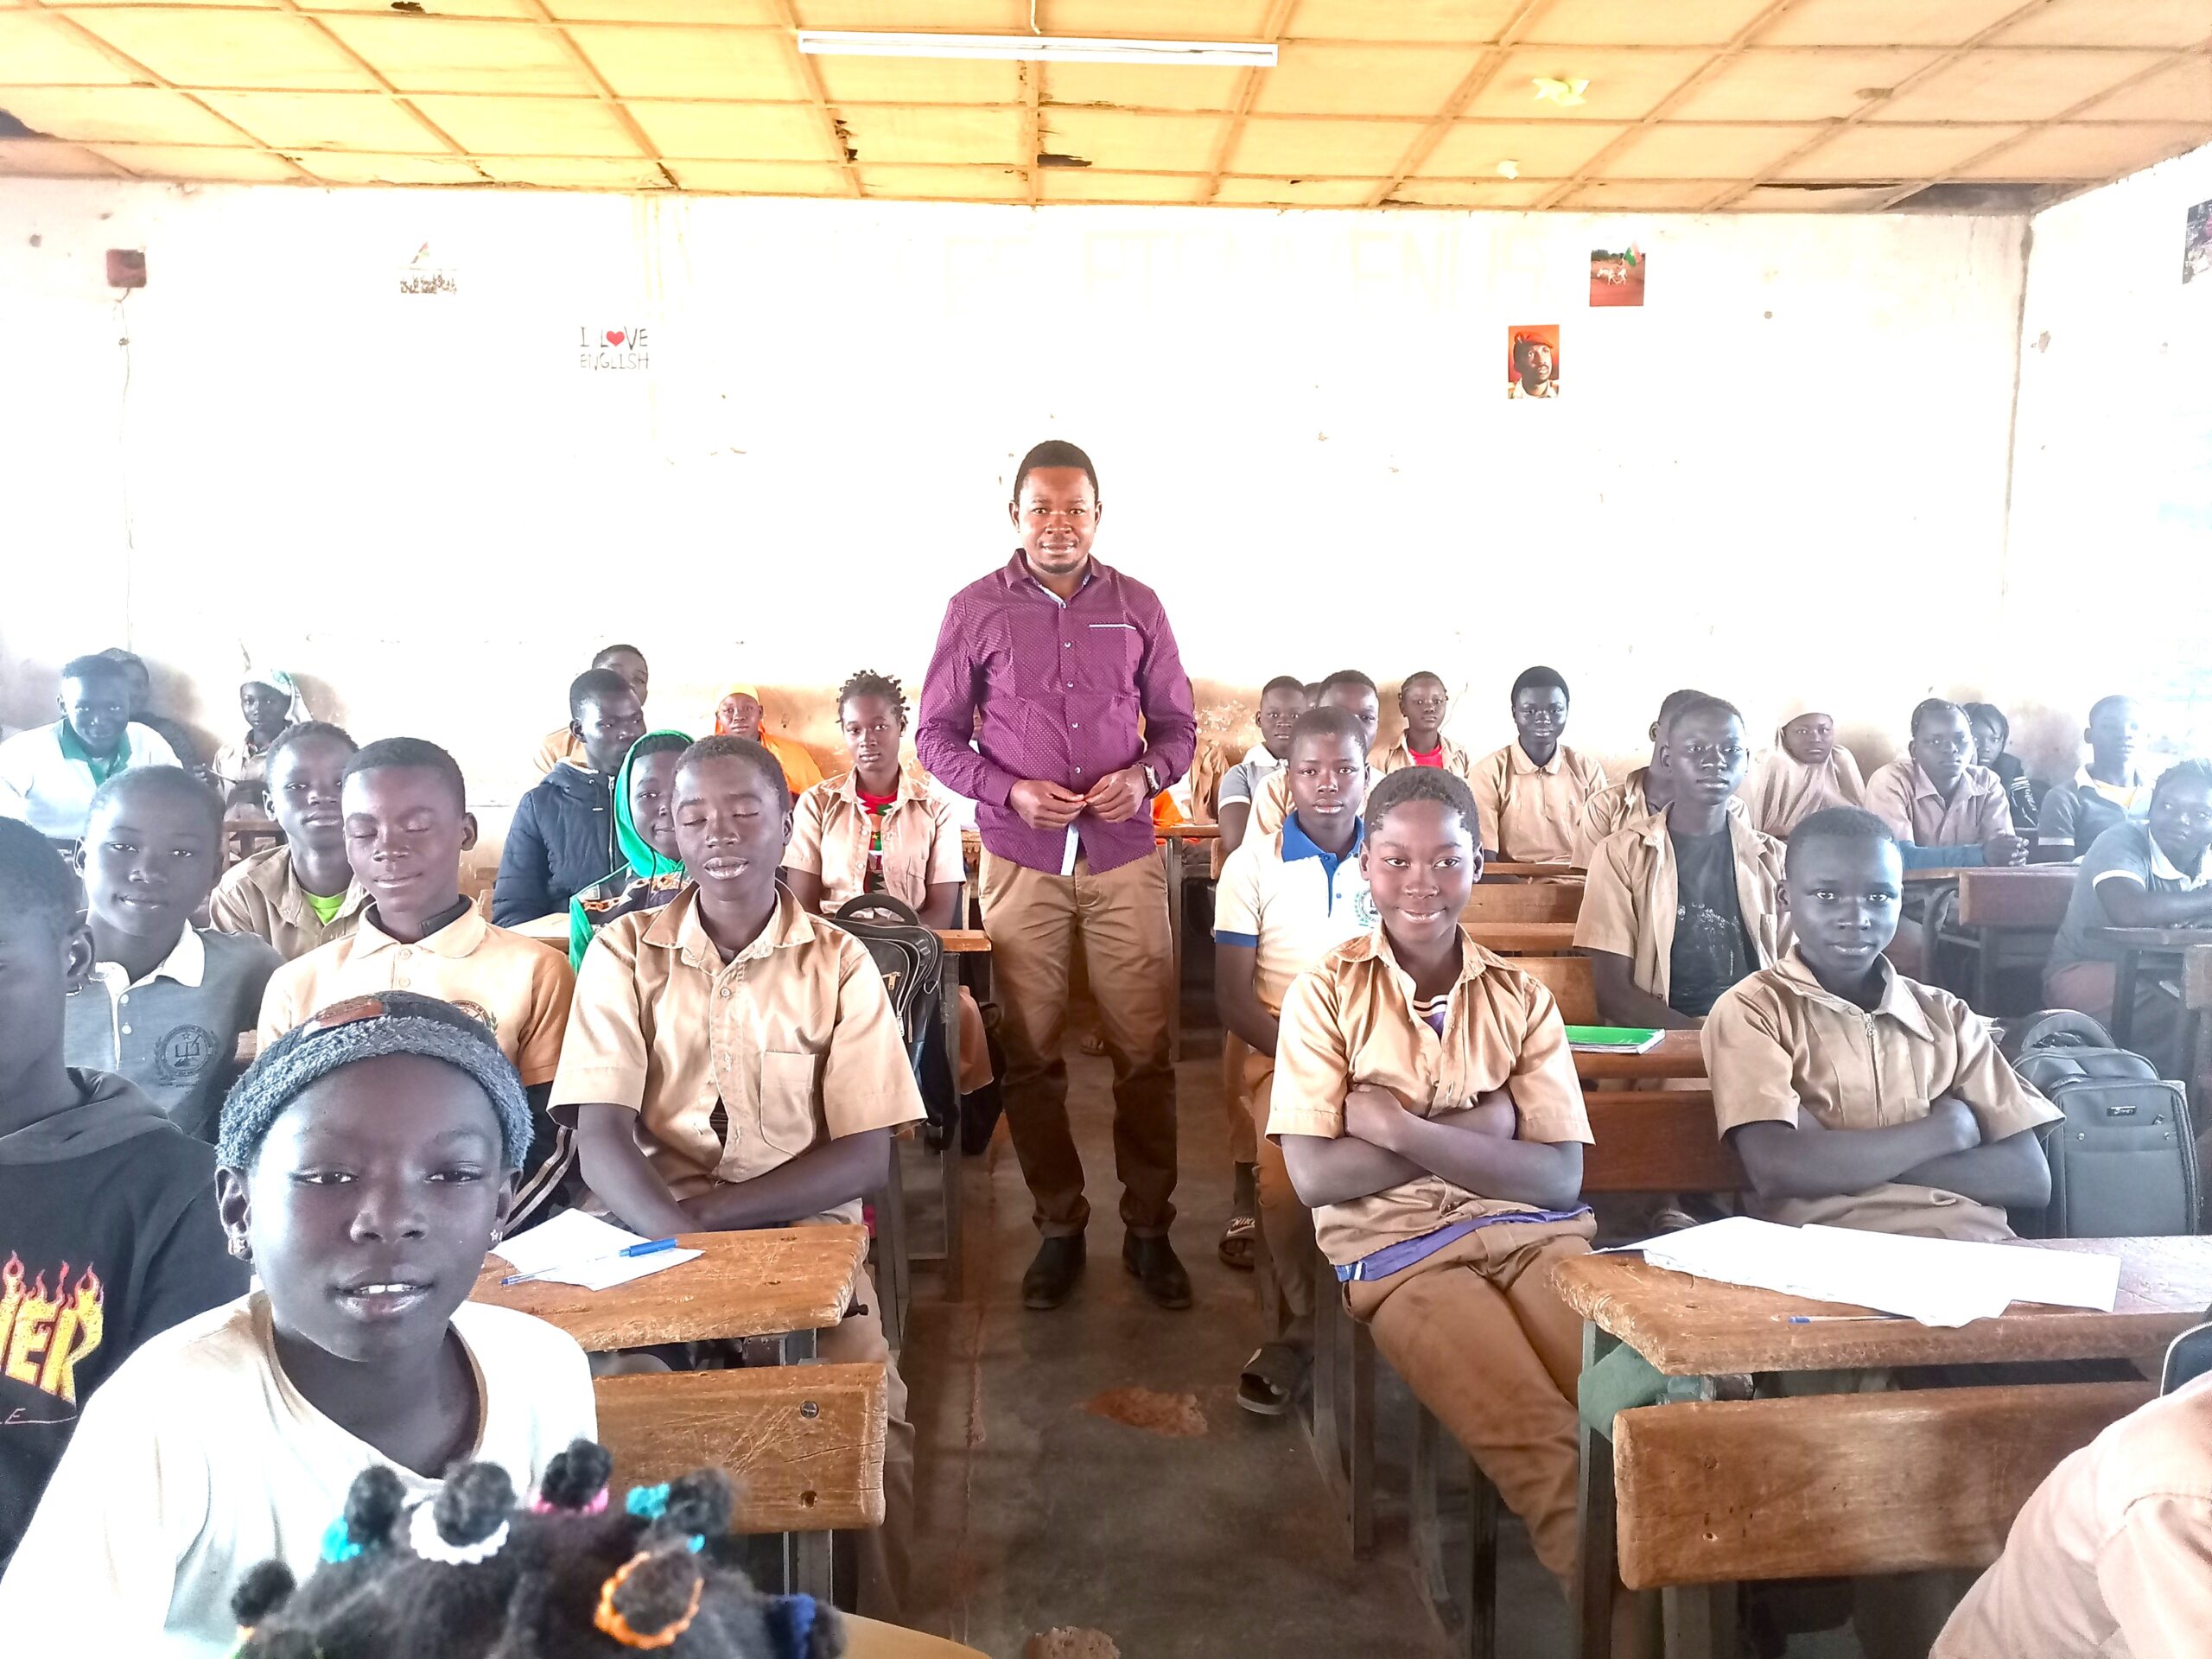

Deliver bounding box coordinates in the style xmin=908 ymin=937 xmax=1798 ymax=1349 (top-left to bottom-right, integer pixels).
xmin=1624 ymin=1217 xmax=2119 ymax=1325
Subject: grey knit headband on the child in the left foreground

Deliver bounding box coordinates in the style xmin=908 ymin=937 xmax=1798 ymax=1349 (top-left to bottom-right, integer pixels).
xmin=214 ymin=991 xmax=531 ymax=1170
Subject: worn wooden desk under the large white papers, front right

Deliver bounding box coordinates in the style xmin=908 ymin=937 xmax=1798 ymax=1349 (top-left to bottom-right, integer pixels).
xmin=1555 ymin=1236 xmax=2212 ymax=1659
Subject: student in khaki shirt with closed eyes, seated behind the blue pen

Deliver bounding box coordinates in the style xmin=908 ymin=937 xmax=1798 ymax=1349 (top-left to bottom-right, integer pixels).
xmin=553 ymin=736 xmax=923 ymax=1617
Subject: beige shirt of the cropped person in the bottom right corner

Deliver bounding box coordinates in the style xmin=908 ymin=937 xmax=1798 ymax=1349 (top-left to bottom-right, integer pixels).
xmin=1929 ymin=1378 xmax=2212 ymax=1659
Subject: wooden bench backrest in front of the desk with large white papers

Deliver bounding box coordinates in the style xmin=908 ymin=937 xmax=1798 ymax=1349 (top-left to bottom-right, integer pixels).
xmin=1612 ymin=1382 xmax=2154 ymax=1591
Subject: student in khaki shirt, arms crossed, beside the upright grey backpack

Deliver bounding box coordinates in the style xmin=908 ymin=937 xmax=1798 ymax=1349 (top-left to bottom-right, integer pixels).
xmin=1701 ymin=807 xmax=2059 ymax=1241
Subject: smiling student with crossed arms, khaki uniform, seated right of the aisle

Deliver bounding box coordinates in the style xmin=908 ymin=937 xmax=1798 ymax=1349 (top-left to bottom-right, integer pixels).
xmin=1268 ymin=767 xmax=1592 ymax=1618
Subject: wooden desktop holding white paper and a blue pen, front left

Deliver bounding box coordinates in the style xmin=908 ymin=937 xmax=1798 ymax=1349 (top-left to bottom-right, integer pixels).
xmin=469 ymin=1225 xmax=868 ymax=1365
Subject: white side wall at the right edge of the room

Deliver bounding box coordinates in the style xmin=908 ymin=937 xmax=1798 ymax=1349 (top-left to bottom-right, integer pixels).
xmin=2004 ymin=149 xmax=2212 ymax=769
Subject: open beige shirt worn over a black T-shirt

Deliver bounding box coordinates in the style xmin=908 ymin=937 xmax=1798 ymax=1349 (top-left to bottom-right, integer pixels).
xmin=1575 ymin=810 xmax=1783 ymax=1002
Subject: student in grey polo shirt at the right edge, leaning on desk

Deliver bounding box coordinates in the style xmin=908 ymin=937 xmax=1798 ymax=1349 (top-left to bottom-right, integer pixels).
xmin=2044 ymin=761 xmax=2212 ymax=1055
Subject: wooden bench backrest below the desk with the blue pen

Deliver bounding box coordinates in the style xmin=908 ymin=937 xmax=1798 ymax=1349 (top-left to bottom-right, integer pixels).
xmin=591 ymin=1365 xmax=885 ymax=1533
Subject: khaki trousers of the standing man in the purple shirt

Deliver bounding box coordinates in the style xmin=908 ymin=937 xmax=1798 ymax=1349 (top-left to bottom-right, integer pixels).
xmin=982 ymin=847 xmax=1174 ymax=1236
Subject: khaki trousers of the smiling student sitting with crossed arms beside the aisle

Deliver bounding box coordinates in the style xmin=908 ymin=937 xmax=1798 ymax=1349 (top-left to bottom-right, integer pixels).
xmin=1344 ymin=1221 xmax=1591 ymax=1604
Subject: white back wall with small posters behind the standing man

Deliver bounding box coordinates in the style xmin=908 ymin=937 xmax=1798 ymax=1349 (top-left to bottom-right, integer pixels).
xmin=0 ymin=181 xmax=2025 ymax=849
